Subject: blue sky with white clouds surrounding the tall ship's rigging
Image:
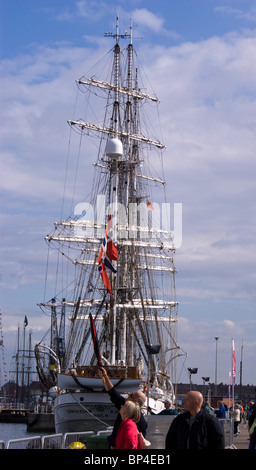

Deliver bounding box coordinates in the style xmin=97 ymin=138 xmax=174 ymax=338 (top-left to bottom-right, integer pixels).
xmin=0 ymin=0 xmax=256 ymax=390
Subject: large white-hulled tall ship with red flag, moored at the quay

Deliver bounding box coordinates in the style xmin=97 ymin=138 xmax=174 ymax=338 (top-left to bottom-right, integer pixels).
xmin=35 ymin=18 xmax=182 ymax=433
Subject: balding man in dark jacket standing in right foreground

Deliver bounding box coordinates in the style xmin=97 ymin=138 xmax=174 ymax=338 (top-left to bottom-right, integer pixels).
xmin=165 ymin=391 xmax=225 ymax=450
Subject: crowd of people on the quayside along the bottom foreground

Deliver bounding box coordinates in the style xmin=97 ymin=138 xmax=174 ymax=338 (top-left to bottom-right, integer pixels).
xmin=99 ymin=368 xmax=256 ymax=450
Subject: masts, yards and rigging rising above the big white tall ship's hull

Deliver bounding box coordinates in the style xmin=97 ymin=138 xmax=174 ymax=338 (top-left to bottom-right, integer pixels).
xmin=40 ymin=18 xmax=177 ymax=384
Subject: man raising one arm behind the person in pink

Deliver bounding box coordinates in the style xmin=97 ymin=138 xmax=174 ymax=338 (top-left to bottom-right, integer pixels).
xmin=99 ymin=367 xmax=148 ymax=449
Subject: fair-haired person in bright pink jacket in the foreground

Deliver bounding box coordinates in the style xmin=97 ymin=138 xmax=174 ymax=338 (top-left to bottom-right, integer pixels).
xmin=116 ymin=401 xmax=140 ymax=449
